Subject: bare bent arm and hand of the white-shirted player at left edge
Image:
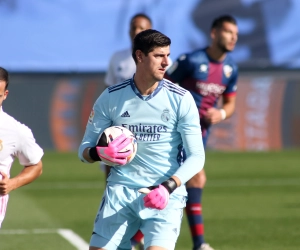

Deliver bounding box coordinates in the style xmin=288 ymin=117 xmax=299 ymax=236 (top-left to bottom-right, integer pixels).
xmin=0 ymin=161 xmax=43 ymax=195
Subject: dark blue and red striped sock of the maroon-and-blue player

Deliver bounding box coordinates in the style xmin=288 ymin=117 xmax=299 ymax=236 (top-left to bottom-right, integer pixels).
xmin=185 ymin=188 xmax=205 ymax=250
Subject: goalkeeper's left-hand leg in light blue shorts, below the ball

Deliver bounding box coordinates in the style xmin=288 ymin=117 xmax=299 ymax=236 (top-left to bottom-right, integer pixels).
xmin=90 ymin=185 xmax=140 ymax=250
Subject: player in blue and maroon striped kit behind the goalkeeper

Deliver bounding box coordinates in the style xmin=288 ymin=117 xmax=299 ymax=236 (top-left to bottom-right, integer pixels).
xmin=166 ymin=15 xmax=238 ymax=250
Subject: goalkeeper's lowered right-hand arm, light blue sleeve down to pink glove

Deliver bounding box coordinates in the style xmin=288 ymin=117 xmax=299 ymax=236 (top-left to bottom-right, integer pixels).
xmin=139 ymin=92 xmax=205 ymax=210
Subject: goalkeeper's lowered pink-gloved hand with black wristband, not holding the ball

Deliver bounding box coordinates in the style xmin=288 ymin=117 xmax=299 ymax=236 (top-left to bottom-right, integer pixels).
xmin=139 ymin=178 xmax=177 ymax=210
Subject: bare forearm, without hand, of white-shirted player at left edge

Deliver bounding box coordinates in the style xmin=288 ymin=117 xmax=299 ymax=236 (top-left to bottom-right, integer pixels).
xmin=9 ymin=161 xmax=43 ymax=190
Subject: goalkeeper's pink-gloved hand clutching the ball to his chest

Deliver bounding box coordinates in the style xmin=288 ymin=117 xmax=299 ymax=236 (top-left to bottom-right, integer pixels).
xmin=90 ymin=134 xmax=132 ymax=165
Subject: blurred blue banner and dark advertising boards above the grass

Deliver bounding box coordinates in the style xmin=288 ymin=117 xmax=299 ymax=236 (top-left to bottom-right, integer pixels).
xmin=0 ymin=0 xmax=300 ymax=151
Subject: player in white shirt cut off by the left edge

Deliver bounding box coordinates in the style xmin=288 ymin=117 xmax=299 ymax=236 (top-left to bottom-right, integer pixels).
xmin=0 ymin=67 xmax=44 ymax=227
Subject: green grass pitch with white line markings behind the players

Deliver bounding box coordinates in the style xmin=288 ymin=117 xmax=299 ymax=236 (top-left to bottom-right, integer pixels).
xmin=0 ymin=150 xmax=300 ymax=250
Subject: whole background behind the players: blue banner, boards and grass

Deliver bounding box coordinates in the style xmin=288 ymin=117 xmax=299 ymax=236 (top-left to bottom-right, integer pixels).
xmin=0 ymin=0 xmax=300 ymax=250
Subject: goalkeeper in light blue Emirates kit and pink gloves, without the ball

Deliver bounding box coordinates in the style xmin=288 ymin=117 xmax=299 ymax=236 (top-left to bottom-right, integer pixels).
xmin=78 ymin=29 xmax=205 ymax=250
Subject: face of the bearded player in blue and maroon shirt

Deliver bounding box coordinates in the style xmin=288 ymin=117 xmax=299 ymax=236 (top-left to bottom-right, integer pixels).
xmin=212 ymin=22 xmax=238 ymax=53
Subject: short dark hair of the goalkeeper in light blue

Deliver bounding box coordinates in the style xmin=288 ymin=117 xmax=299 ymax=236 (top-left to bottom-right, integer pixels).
xmin=132 ymin=29 xmax=171 ymax=62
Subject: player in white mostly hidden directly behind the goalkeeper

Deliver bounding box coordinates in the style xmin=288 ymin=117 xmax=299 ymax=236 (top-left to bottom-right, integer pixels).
xmin=105 ymin=13 xmax=152 ymax=250
